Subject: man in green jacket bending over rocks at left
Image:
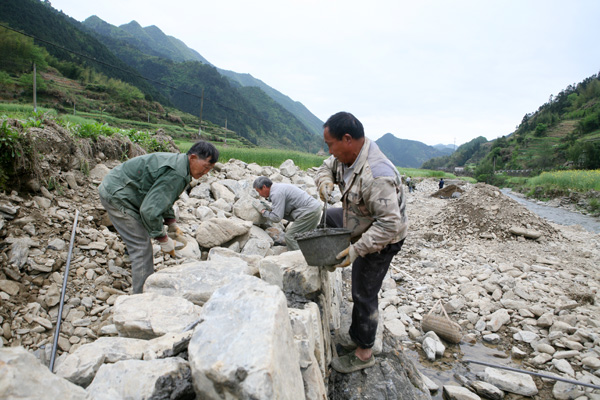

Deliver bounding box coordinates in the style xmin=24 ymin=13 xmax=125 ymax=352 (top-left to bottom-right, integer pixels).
xmin=98 ymin=141 xmax=219 ymax=293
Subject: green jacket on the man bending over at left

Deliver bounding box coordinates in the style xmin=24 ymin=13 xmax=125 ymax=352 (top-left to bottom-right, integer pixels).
xmin=98 ymin=153 xmax=192 ymax=238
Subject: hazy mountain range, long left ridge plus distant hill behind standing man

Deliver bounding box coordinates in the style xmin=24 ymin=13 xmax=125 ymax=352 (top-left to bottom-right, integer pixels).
xmin=0 ymin=0 xmax=460 ymax=167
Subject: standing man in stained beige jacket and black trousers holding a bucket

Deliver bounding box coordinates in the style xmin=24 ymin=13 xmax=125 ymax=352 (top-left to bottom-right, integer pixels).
xmin=316 ymin=112 xmax=408 ymax=373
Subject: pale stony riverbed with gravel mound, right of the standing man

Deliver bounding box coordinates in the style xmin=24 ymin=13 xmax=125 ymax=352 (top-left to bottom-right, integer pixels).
xmin=394 ymin=181 xmax=600 ymax=399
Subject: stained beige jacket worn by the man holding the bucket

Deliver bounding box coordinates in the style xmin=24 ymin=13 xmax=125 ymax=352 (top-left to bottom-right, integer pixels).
xmin=316 ymin=138 xmax=408 ymax=256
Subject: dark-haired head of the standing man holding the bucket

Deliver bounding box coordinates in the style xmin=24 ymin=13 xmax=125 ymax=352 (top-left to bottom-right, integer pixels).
xmin=323 ymin=111 xmax=365 ymax=165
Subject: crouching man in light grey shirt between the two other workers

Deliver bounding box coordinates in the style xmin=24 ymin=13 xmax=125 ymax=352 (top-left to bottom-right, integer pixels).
xmin=252 ymin=176 xmax=321 ymax=251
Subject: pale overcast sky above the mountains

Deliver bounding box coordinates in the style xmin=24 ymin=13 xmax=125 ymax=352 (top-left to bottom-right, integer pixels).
xmin=51 ymin=0 xmax=600 ymax=146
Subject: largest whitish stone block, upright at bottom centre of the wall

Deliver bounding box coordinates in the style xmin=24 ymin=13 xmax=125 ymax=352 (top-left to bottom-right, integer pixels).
xmin=188 ymin=276 xmax=305 ymax=400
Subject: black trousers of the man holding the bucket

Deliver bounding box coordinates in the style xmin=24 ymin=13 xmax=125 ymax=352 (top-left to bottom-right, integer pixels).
xmin=327 ymin=208 xmax=404 ymax=349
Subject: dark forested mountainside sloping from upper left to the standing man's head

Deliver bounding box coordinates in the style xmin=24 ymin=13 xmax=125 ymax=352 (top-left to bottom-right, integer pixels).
xmin=0 ymin=0 xmax=322 ymax=152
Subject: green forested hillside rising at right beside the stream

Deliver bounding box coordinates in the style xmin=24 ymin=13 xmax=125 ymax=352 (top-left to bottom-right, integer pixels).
xmin=422 ymin=74 xmax=600 ymax=176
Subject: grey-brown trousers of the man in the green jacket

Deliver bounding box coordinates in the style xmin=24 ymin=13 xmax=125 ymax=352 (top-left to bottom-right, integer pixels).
xmin=100 ymin=196 xmax=154 ymax=294
